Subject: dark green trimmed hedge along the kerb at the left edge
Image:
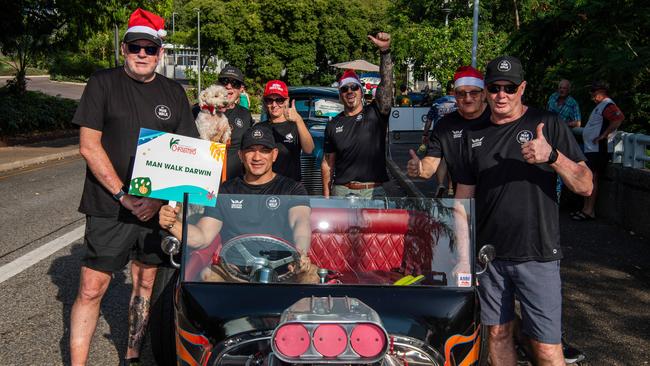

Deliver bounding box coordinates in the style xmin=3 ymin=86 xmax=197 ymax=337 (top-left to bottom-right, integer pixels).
xmin=0 ymin=87 xmax=77 ymax=137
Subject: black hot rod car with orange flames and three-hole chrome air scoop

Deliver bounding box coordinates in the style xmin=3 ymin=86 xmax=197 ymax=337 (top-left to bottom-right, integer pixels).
xmin=151 ymin=195 xmax=493 ymax=366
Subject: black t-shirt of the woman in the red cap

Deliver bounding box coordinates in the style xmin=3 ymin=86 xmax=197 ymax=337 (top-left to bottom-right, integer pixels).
xmin=262 ymin=121 xmax=302 ymax=182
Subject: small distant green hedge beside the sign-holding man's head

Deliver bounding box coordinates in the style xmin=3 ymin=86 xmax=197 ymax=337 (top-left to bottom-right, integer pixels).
xmin=50 ymin=52 xmax=110 ymax=81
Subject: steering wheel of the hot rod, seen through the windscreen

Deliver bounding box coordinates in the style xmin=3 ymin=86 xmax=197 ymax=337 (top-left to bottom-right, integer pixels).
xmin=219 ymin=234 xmax=300 ymax=282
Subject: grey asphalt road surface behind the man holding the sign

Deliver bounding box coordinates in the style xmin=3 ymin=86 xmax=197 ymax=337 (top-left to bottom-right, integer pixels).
xmin=0 ymin=159 xmax=153 ymax=366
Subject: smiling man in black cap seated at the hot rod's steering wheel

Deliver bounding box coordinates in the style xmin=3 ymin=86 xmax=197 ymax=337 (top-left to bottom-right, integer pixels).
xmin=159 ymin=125 xmax=318 ymax=282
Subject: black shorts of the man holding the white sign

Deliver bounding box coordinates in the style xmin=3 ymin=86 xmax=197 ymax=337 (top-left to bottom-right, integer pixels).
xmin=82 ymin=216 xmax=167 ymax=272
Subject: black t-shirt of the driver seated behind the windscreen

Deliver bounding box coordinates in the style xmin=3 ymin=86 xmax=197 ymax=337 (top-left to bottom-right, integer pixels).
xmin=205 ymin=174 xmax=309 ymax=243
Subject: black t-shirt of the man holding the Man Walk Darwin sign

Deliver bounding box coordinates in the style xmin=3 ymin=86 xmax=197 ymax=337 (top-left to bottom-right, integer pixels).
xmin=72 ymin=67 xmax=199 ymax=218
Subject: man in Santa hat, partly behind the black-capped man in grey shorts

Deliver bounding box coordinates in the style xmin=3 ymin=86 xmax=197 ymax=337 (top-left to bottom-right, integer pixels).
xmin=406 ymin=66 xmax=490 ymax=197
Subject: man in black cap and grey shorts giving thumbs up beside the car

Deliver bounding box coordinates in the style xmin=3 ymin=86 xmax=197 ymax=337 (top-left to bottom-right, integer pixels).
xmin=455 ymin=56 xmax=593 ymax=365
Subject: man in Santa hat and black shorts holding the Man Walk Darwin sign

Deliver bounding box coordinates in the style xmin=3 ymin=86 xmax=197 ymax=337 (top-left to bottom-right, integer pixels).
xmin=70 ymin=9 xmax=198 ymax=365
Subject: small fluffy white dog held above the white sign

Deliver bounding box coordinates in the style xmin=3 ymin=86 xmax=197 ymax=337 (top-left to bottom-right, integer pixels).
xmin=195 ymin=85 xmax=232 ymax=144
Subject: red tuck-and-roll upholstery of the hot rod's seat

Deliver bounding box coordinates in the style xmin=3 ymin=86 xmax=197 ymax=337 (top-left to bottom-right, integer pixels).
xmin=186 ymin=208 xmax=439 ymax=280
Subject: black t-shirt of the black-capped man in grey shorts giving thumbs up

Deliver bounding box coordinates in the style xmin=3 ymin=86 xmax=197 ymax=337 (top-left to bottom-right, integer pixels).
xmin=456 ymin=107 xmax=585 ymax=261
